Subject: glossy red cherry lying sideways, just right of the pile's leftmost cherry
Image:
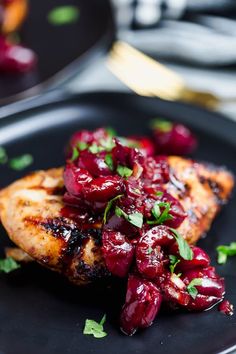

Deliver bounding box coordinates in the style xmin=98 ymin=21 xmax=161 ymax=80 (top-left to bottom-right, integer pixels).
xmin=84 ymin=176 xmax=124 ymax=202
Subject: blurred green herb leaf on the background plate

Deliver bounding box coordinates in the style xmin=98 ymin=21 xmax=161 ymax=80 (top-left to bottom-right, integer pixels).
xmin=47 ymin=5 xmax=79 ymax=26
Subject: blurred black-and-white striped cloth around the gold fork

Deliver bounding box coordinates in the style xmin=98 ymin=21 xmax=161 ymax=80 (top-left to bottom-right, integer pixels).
xmin=70 ymin=0 xmax=236 ymax=120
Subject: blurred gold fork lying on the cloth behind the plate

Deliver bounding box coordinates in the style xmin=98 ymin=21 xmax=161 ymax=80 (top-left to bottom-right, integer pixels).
xmin=107 ymin=41 xmax=229 ymax=109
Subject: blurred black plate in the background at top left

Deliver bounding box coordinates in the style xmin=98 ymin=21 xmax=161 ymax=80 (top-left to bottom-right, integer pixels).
xmin=0 ymin=0 xmax=115 ymax=104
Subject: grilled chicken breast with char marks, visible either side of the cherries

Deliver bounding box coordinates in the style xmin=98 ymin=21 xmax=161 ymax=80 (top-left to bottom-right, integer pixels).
xmin=0 ymin=157 xmax=234 ymax=284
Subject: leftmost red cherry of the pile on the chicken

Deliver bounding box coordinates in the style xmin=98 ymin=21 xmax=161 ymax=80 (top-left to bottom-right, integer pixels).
xmin=63 ymin=164 xmax=92 ymax=196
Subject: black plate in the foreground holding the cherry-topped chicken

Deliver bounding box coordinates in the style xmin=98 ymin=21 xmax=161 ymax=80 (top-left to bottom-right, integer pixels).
xmin=0 ymin=93 xmax=236 ymax=354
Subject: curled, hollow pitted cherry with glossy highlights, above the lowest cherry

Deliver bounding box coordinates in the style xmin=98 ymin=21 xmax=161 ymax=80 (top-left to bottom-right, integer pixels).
xmin=136 ymin=225 xmax=175 ymax=279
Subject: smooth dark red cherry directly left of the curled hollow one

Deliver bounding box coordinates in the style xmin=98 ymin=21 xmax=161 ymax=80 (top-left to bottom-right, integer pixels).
xmin=102 ymin=230 xmax=134 ymax=277
